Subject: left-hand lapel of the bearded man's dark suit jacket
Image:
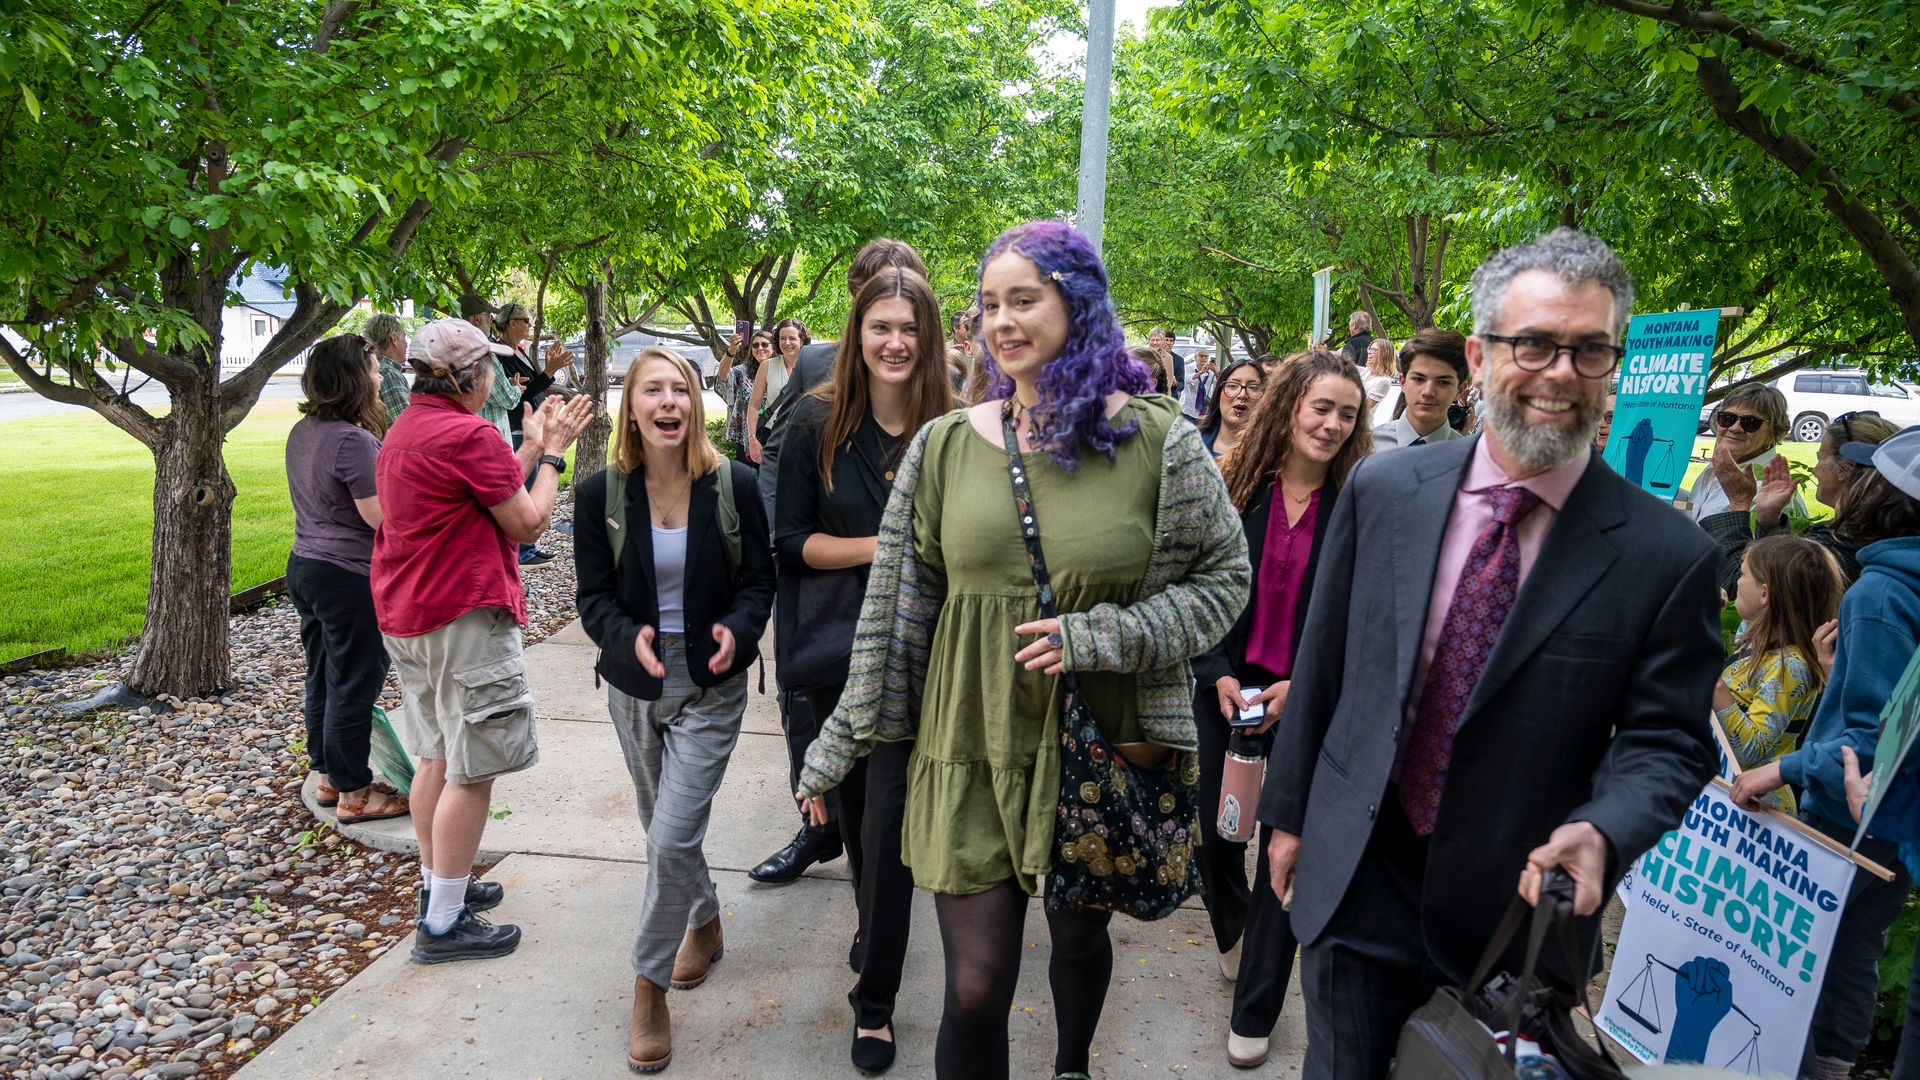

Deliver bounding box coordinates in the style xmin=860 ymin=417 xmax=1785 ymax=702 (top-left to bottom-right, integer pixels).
xmin=1377 ymin=438 xmax=1476 ymax=709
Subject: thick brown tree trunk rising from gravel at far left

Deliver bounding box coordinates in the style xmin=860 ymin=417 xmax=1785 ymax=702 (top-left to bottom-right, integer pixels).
xmin=127 ymin=365 xmax=234 ymax=698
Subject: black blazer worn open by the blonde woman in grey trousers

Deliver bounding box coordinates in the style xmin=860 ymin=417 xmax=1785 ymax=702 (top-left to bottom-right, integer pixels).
xmin=574 ymin=457 xmax=774 ymax=701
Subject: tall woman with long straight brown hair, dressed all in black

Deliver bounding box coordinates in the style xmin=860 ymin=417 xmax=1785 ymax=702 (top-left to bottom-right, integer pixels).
xmin=774 ymin=269 xmax=954 ymax=1072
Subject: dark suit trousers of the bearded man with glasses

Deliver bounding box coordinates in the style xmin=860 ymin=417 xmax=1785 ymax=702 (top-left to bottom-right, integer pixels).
xmin=1290 ymin=788 xmax=1443 ymax=1080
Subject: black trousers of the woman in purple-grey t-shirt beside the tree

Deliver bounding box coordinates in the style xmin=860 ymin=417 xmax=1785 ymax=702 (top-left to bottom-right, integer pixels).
xmin=286 ymin=555 xmax=388 ymax=792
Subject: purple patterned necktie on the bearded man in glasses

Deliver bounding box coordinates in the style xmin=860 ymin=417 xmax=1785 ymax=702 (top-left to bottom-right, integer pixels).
xmin=1400 ymin=480 xmax=1540 ymax=836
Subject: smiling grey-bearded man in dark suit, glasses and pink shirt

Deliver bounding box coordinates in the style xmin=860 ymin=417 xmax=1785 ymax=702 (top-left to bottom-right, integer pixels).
xmin=1260 ymin=229 xmax=1722 ymax=1080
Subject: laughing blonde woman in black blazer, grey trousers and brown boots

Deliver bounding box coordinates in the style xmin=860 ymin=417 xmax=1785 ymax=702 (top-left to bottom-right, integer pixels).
xmin=574 ymin=348 xmax=774 ymax=1072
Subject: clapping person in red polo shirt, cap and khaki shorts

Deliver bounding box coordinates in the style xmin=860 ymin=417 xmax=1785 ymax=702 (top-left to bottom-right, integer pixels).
xmin=372 ymin=319 xmax=593 ymax=963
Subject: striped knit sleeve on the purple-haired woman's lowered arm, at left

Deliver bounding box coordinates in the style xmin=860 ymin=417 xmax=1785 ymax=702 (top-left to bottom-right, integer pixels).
xmin=799 ymin=421 xmax=947 ymax=798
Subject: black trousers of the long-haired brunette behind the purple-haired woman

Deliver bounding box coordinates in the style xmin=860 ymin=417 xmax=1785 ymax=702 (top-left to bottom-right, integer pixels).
xmin=828 ymin=726 xmax=914 ymax=1028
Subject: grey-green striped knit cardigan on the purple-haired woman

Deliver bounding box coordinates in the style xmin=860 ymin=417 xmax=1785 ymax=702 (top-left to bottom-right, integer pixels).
xmin=799 ymin=403 xmax=1254 ymax=798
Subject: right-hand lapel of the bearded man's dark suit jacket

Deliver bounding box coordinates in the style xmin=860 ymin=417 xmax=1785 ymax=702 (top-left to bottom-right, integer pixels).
xmin=1461 ymin=454 xmax=1626 ymax=724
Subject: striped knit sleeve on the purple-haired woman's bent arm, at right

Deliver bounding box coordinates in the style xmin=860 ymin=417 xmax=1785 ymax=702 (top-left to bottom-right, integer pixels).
xmin=1060 ymin=421 xmax=1254 ymax=673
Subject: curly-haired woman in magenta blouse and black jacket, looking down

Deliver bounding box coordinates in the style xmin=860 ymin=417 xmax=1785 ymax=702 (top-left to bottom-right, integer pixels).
xmin=1192 ymin=350 xmax=1373 ymax=1068
